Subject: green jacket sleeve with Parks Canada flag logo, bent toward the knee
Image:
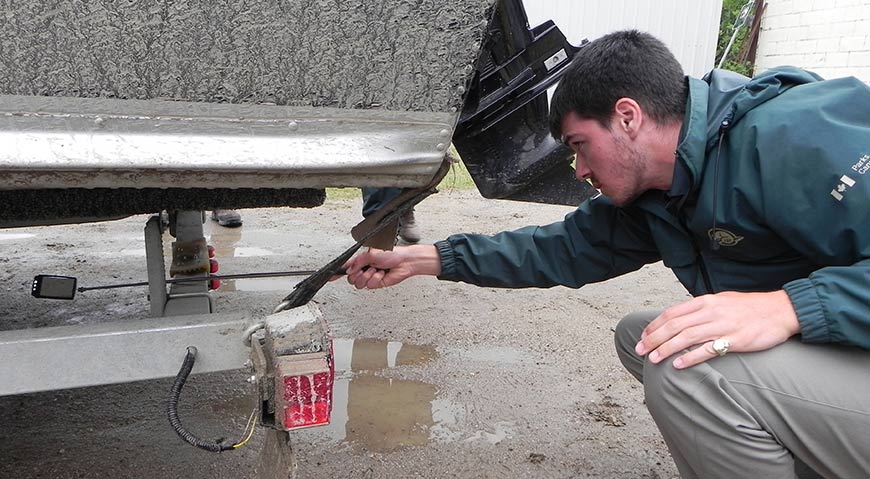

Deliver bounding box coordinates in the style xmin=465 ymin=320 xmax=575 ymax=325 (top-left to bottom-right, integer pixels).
xmin=756 ymin=79 xmax=870 ymax=349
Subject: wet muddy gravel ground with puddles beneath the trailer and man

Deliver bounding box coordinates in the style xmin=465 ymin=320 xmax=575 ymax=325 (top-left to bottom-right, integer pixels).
xmin=0 ymin=191 xmax=687 ymax=478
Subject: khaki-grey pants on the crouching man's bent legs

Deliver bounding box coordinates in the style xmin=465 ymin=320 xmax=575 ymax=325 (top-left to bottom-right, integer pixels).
xmin=615 ymin=312 xmax=870 ymax=479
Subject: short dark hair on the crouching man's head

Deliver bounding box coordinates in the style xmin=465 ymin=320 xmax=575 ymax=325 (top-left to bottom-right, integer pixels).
xmin=550 ymin=30 xmax=687 ymax=140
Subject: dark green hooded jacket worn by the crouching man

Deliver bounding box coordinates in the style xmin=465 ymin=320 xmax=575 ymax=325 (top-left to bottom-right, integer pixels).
xmin=436 ymin=67 xmax=870 ymax=349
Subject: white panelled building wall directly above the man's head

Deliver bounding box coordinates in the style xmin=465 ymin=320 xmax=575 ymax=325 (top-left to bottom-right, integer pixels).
xmin=523 ymin=0 xmax=722 ymax=77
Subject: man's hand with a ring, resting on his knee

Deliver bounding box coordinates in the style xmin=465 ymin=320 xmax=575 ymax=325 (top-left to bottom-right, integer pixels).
xmin=635 ymin=290 xmax=800 ymax=369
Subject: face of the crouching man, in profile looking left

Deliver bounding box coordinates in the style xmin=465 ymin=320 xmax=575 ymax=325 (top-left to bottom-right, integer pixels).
xmin=562 ymin=112 xmax=646 ymax=206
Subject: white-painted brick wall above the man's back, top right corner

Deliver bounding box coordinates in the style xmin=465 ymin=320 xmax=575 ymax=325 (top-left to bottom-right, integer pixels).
xmin=755 ymin=0 xmax=870 ymax=83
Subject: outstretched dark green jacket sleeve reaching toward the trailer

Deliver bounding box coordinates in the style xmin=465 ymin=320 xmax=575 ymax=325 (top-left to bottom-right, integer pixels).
xmin=436 ymin=196 xmax=660 ymax=288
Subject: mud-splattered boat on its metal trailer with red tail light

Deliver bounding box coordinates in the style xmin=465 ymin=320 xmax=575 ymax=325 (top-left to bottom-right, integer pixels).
xmin=0 ymin=0 xmax=593 ymax=472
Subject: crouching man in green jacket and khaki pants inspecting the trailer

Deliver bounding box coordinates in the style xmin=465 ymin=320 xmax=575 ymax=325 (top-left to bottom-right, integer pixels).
xmin=347 ymin=31 xmax=870 ymax=478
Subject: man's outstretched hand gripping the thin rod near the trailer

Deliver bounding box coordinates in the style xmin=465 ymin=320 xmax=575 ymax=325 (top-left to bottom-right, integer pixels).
xmin=344 ymin=245 xmax=441 ymax=289
